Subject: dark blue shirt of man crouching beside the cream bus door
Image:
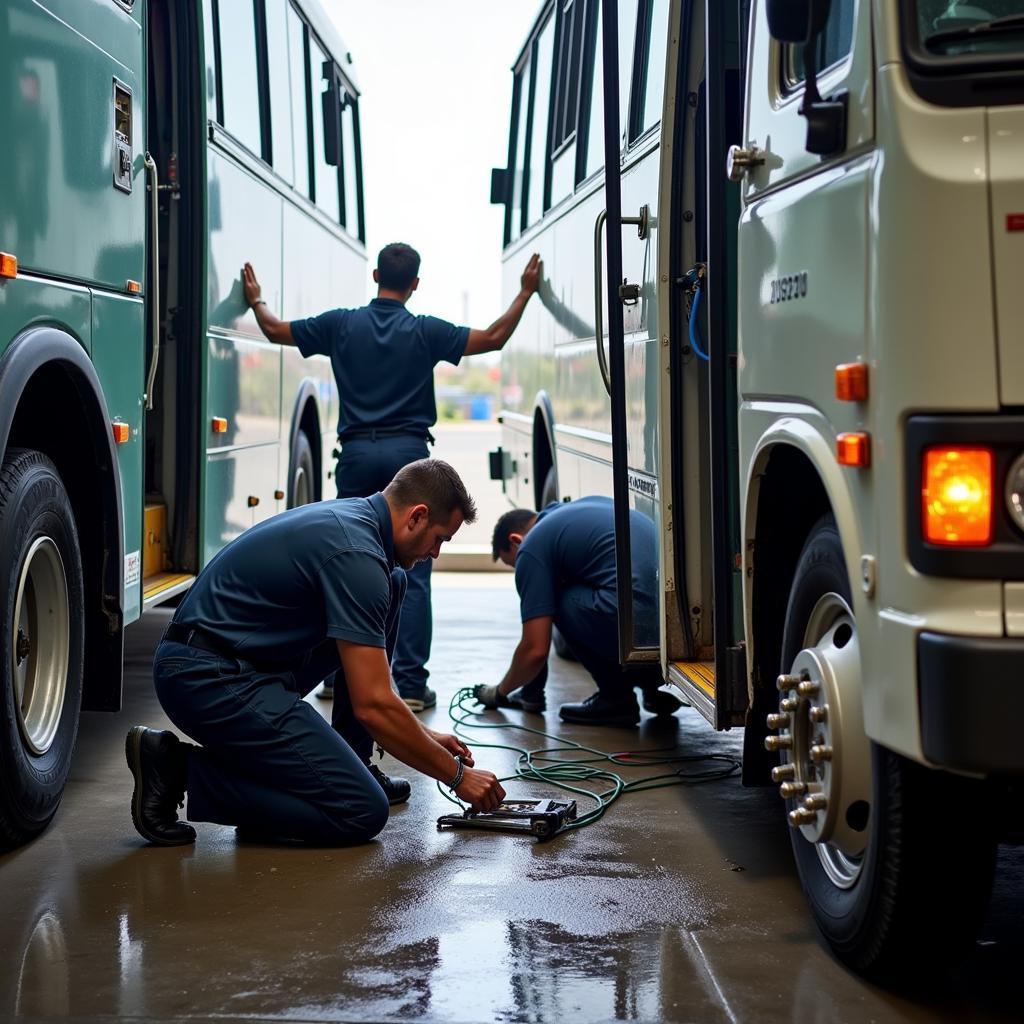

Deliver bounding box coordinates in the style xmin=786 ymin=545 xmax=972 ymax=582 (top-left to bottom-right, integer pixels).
xmin=515 ymin=496 xmax=658 ymax=633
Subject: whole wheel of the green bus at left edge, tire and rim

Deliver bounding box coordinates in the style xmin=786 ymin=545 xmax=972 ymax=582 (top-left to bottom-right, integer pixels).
xmin=0 ymin=449 xmax=85 ymax=846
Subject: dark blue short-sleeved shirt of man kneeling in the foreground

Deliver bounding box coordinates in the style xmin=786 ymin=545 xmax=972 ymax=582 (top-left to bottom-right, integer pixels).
xmin=174 ymin=493 xmax=394 ymax=666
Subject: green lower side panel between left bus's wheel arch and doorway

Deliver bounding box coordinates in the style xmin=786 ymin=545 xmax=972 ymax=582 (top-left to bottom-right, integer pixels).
xmin=92 ymin=292 xmax=145 ymax=625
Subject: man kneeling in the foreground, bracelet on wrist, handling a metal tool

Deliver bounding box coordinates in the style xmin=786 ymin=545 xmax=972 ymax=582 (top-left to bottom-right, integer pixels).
xmin=126 ymin=459 xmax=505 ymax=846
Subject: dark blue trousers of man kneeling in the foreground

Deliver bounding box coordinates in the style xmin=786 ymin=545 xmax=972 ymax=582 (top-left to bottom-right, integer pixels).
xmin=154 ymin=568 xmax=406 ymax=843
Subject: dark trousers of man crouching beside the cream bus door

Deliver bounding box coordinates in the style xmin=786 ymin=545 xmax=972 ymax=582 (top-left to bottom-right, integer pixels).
xmin=527 ymin=584 xmax=662 ymax=703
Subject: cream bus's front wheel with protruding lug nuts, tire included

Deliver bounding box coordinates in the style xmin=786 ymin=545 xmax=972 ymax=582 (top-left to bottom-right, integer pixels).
xmin=767 ymin=515 xmax=995 ymax=980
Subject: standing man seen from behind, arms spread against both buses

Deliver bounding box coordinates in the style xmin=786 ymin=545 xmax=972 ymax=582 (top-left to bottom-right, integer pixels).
xmin=243 ymin=242 xmax=542 ymax=712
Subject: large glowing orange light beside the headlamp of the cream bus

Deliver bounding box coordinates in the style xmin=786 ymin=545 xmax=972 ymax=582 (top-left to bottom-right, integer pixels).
xmin=921 ymin=447 xmax=994 ymax=548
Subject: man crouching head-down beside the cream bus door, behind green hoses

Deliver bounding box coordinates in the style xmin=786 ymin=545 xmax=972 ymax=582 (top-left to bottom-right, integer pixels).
xmin=474 ymin=497 xmax=680 ymax=725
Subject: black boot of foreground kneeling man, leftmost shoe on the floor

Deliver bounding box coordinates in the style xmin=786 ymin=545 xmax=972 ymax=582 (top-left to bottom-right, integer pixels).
xmin=125 ymin=725 xmax=196 ymax=846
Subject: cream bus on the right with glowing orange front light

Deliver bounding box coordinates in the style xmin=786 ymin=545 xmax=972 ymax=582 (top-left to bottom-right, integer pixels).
xmin=492 ymin=0 xmax=1024 ymax=978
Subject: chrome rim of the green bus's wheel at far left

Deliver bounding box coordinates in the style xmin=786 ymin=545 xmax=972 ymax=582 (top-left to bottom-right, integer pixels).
xmin=10 ymin=537 xmax=71 ymax=757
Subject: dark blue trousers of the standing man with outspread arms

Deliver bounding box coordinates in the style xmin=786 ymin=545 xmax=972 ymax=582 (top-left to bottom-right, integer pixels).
xmin=336 ymin=434 xmax=433 ymax=697
